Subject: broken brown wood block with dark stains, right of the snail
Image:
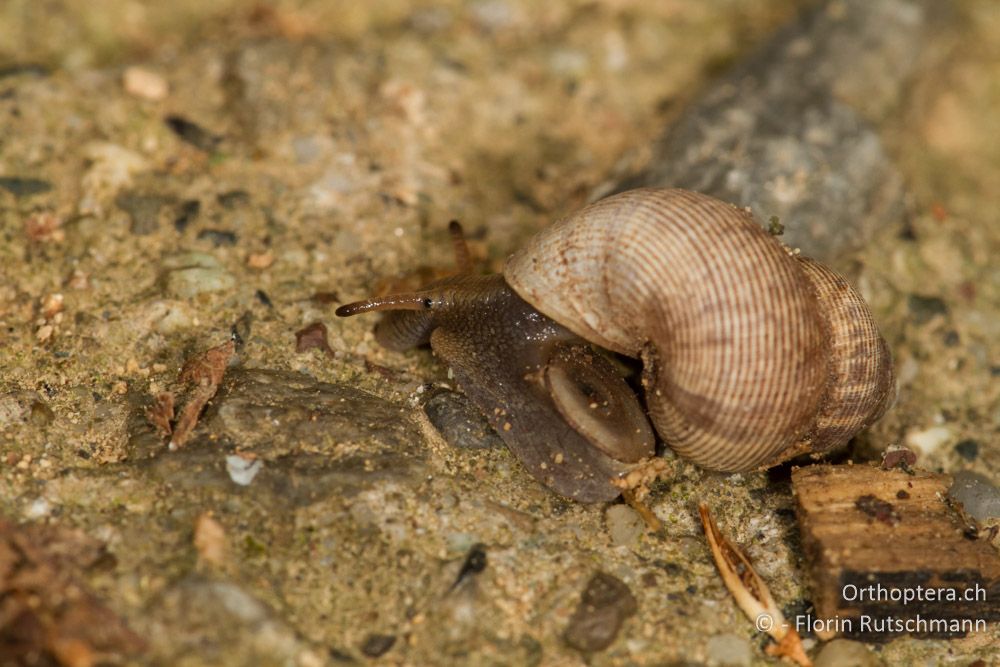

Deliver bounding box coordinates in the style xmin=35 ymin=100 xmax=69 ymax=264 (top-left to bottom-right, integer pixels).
xmin=792 ymin=465 xmax=1000 ymax=641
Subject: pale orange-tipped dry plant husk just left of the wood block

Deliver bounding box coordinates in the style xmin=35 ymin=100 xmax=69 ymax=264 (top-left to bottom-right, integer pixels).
xmin=698 ymin=503 xmax=812 ymax=667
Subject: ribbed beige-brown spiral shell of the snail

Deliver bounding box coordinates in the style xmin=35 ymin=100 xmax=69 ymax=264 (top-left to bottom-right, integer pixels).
xmin=504 ymin=189 xmax=894 ymax=471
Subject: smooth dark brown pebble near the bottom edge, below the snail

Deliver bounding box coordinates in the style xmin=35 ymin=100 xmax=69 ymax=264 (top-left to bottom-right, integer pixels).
xmin=564 ymin=572 xmax=638 ymax=653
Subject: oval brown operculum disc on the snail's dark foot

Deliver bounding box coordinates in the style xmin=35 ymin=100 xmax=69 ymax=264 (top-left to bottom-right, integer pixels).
xmin=545 ymin=345 xmax=655 ymax=463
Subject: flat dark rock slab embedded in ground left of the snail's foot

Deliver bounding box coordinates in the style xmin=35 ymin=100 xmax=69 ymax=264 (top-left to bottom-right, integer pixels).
xmin=127 ymin=367 xmax=427 ymax=507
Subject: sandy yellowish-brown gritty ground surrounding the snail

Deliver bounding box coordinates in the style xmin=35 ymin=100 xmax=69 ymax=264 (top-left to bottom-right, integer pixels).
xmin=0 ymin=0 xmax=1000 ymax=665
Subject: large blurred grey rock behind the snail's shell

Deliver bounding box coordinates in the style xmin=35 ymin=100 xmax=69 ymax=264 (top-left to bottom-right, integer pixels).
xmin=614 ymin=0 xmax=943 ymax=264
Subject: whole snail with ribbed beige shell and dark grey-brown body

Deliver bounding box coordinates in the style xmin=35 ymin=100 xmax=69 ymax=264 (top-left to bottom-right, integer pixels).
xmin=337 ymin=188 xmax=895 ymax=502
